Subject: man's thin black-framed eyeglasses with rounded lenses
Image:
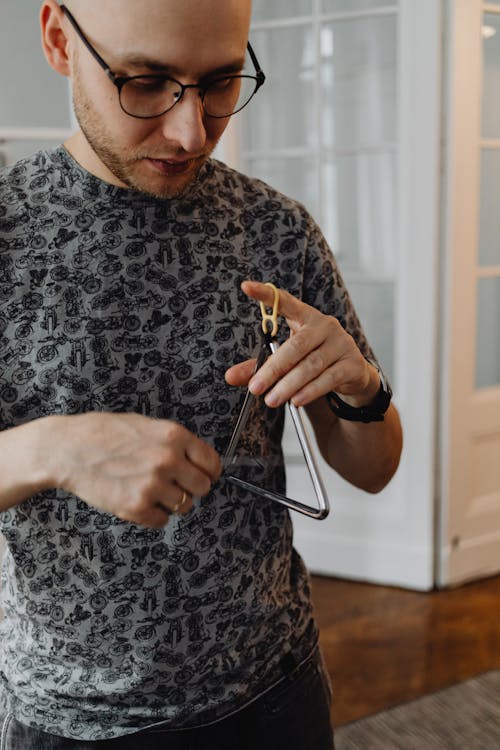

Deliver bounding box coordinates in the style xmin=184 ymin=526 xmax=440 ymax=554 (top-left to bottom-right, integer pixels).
xmin=60 ymin=5 xmax=266 ymax=120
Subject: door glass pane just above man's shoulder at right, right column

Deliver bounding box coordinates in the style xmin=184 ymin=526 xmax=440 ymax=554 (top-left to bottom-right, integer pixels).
xmin=322 ymin=152 xmax=397 ymax=277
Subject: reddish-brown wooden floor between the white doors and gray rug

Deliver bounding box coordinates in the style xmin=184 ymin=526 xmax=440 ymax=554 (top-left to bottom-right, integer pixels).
xmin=313 ymin=576 xmax=500 ymax=726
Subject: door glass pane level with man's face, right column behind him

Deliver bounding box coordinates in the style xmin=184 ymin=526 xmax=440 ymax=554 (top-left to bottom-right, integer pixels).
xmin=321 ymin=16 xmax=397 ymax=148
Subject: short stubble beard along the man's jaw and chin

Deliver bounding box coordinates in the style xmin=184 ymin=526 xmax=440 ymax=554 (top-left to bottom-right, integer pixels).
xmin=73 ymin=76 xmax=210 ymax=199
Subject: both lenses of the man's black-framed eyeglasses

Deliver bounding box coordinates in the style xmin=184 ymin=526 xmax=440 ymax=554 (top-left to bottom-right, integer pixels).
xmin=120 ymin=76 xmax=257 ymax=117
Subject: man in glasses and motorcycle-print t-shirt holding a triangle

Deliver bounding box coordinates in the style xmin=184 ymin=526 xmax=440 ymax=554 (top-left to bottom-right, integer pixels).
xmin=0 ymin=0 xmax=401 ymax=750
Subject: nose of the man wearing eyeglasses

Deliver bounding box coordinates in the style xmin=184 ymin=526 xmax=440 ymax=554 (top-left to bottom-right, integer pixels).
xmin=161 ymin=88 xmax=207 ymax=154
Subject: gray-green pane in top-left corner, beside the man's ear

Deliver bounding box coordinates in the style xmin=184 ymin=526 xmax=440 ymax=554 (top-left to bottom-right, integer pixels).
xmin=0 ymin=0 xmax=70 ymax=127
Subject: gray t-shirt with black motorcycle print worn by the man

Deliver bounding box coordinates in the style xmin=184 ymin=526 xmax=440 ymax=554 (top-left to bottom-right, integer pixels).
xmin=0 ymin=147 xmax=369 ymax=740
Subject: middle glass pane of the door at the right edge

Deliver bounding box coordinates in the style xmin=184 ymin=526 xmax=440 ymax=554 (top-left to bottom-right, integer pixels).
xmin=479 ymin=149 xmax=500 ymax=266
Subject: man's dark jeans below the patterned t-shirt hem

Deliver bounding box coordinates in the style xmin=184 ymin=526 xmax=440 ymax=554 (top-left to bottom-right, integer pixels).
xmin=0 ymin=652 xmax=334 ymax=750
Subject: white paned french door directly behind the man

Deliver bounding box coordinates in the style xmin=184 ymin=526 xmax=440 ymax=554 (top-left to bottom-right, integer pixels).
xmin=222 ymin=0 xmax=441 ymax=589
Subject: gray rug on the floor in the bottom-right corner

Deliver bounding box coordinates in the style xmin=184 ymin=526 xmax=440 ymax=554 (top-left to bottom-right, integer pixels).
xmin=335 ymin=669 xmax=500 ymax=750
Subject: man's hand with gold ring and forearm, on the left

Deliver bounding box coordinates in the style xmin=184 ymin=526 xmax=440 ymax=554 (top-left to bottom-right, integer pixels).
xmin=0 ymin=412 xmax=222 ymax=528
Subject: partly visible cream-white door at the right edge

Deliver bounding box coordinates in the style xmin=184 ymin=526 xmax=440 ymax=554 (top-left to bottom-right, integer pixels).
xmin=439 ymin=0 xmax=500 ymax=584
